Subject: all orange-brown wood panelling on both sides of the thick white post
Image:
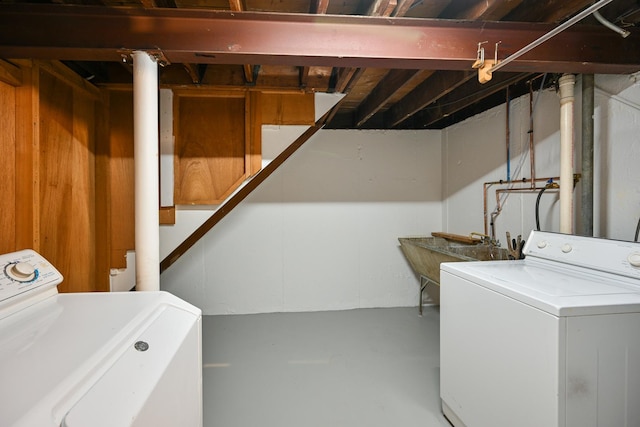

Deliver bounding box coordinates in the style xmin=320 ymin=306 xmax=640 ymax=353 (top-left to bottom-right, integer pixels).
xmin=0 ymin=60 xmax=314 ymax=292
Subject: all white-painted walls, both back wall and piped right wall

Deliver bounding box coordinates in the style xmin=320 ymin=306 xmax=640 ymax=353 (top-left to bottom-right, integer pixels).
xmin=161 ymin=76 xmax=640 ymax=314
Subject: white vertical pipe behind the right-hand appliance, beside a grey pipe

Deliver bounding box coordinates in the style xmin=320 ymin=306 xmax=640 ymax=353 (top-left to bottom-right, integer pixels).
xmin=559 ymin=74 xmax=576 ymax=234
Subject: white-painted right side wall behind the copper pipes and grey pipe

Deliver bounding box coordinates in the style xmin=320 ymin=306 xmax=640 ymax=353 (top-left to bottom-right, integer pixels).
xmin=442 ymin=75 xmax=640 ymax=245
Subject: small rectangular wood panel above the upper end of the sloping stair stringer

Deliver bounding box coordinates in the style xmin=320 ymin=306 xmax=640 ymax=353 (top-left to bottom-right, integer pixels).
xmin=260 ymin=92 xmax=316 ymax=126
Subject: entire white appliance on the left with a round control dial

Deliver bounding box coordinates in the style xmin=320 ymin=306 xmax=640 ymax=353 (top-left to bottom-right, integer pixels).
xmin=0 ymin=250 xmax=202 ymax=427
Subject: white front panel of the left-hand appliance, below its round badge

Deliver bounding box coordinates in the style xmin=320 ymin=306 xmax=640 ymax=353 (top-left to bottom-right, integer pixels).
xmin=62 ymin=306 xmax=202 ymax=427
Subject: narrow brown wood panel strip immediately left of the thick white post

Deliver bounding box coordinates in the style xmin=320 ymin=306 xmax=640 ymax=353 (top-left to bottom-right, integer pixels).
xmin=109 ymin=90 xmax=135 ymax=268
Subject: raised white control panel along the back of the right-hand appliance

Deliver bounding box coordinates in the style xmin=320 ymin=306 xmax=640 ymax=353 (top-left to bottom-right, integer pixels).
xmin=524 ymin=230 xmax=640 ymax=279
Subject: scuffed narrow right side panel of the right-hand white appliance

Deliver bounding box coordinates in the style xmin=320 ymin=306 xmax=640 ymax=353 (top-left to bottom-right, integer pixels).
xmin=566 ymin=313 xmax=640 ymax=427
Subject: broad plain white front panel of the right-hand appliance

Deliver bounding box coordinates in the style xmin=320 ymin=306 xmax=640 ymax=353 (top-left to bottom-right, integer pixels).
xmin=440 ymin=271 xmax=564 ymax=427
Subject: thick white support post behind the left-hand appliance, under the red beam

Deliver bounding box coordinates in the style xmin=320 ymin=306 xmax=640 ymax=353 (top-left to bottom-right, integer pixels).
xmin=132 ymin=52 xmax=160 ymax=291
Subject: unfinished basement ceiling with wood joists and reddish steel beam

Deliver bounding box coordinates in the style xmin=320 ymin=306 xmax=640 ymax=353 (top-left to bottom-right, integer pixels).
xmin=0 ymin=0 xmax=640 ymax=129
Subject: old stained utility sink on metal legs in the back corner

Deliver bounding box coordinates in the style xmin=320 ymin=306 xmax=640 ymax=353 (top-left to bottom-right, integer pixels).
xmin=398 ymin=237 xmax=509 ymax=313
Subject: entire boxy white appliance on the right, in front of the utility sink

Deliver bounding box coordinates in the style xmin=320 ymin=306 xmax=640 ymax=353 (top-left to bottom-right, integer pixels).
xmin=440 ymin=232 xmax=640 ymax=427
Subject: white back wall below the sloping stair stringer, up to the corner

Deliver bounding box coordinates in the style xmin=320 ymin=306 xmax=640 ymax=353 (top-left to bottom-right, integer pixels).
xmin=161 ymin=130 xmax=442 ymax=314
